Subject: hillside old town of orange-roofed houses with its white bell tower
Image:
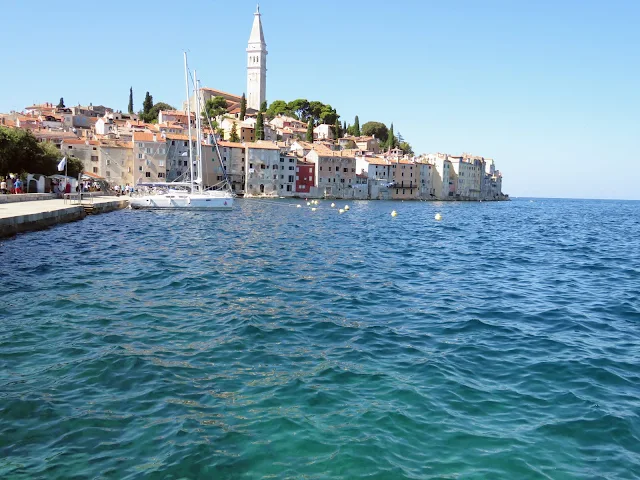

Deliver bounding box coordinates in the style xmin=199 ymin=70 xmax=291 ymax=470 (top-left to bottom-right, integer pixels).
xmin=0 ymin=9 xmax=508 ymax=201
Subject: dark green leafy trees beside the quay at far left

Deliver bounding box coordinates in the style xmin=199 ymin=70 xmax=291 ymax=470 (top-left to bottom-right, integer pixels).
xmin=0 ymin=127 xmax=83 ymax=177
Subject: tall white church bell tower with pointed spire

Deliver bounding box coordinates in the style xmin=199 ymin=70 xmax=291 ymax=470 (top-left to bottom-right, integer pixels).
xmin=247 ymin=5 xmax=268 ymax=110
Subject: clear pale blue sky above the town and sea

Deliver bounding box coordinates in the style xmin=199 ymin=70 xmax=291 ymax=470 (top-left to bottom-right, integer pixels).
xmin=0 ymin=0 xmax=640 ymax=199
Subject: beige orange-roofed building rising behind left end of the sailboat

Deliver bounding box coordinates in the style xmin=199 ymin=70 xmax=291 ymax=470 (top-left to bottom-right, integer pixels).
xmin=132 ymin=131 xmax=167 ymax=183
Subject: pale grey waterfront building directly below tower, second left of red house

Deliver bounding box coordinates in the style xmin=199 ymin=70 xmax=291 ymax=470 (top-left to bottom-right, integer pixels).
xmin=245 ymin=141 xmax=280 ymax=196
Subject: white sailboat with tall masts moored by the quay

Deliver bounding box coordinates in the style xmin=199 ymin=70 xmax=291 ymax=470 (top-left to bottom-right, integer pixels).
xmin=129 ymin=52 xmax=234 ymax=210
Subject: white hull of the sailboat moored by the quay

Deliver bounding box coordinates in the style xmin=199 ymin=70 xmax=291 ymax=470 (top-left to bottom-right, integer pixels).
xmin=129 ymin=192 xmax=233 ymax=210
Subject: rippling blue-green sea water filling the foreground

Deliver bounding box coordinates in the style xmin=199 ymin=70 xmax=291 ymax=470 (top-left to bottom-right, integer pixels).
xmin=0 ymin=200 xmax=640 ymax=479
